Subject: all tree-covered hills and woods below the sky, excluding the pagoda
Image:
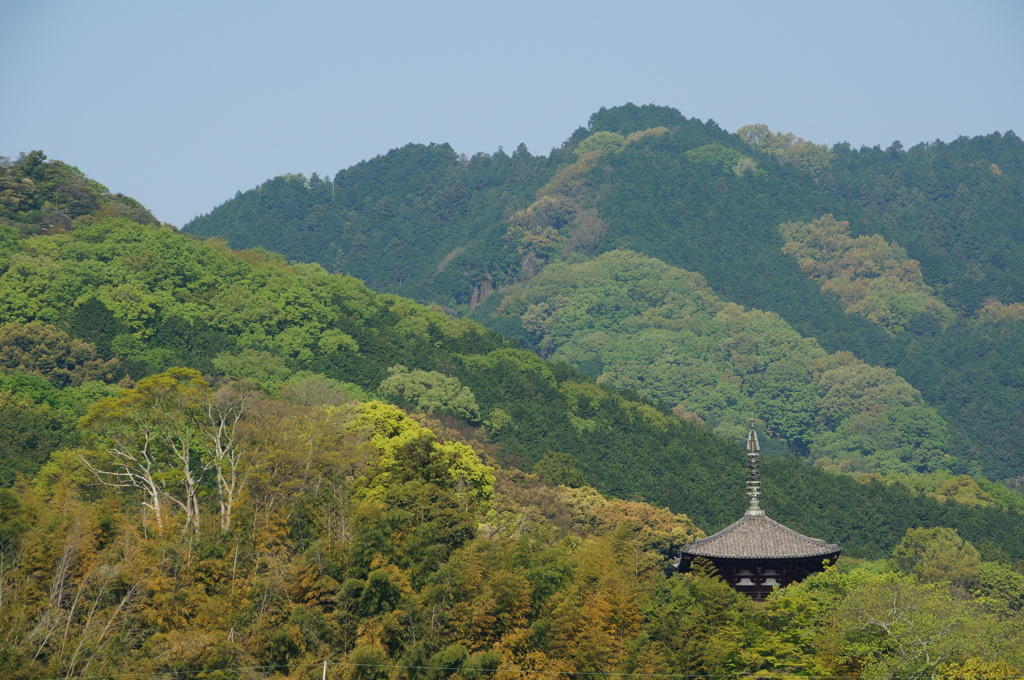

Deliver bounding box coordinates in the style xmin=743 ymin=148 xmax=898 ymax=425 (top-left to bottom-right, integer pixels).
xmin=6 ymin=104 xmax=1024 ymax=680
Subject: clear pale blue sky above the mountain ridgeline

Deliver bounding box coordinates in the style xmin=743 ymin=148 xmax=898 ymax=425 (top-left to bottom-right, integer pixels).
xmin=0 ymin=0 xmax=1024 ymax=226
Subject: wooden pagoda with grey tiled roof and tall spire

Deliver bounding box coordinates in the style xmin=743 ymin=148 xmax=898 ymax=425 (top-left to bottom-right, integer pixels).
xmin=679 ymin=421 xmax=843 ymax=601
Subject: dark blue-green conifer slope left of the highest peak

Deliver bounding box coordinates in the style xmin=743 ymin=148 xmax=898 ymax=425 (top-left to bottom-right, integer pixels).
xmin=183 ymin=144 xmax=557 ymax=307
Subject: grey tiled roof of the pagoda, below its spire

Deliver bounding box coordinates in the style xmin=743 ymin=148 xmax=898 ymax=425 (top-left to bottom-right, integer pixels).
xmin=683 ymin=515 xmax=842 ymax=559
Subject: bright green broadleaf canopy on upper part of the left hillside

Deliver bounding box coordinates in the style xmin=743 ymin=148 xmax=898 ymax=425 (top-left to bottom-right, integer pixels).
xmin=0 ymin=219 xmax=452 ymax=378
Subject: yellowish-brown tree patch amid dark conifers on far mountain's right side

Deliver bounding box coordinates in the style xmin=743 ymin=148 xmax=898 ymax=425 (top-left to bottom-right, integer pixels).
xmin=779 ymin=215 xmax=952 ymax=333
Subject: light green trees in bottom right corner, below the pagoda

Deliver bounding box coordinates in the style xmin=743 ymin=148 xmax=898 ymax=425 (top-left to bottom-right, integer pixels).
xmin=713 ymin=568 xmax=1020 ymax=678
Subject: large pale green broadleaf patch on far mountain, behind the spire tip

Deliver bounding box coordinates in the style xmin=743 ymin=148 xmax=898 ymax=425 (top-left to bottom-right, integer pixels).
xmin=498 ymin=251 xmax=949 ymax=472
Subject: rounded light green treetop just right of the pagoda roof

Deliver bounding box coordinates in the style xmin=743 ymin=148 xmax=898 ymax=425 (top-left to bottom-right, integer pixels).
xmin=890 ymin=526 xmax=981 ymax=589
